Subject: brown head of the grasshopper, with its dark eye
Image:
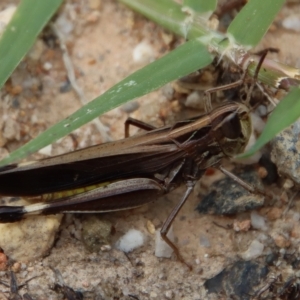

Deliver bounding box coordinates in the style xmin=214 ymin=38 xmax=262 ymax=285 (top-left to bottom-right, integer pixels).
xmin=212 ymin=102 xmax=252 ymax=157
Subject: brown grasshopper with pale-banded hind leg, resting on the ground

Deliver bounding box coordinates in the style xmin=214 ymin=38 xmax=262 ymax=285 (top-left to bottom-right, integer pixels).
xmin=0 ymin=102 xmax=251 ymax=262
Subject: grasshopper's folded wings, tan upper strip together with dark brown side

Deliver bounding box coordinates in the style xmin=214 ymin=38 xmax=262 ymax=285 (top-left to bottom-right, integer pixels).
xmin=0 ymin=116 xmax=211 ymax=196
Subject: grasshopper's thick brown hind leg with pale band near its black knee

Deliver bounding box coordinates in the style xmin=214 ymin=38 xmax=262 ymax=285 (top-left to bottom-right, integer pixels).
xmin=0 ymin=178 xmax=165 ymax=223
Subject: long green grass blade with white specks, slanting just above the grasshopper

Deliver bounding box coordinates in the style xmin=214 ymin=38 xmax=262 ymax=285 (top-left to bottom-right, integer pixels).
xmin=0 ymin=40 xmax=213 ymax=165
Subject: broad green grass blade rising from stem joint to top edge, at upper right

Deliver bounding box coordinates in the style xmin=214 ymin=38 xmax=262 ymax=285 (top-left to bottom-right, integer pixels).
xmin=227 ymin=0 xmax=285 ymax=48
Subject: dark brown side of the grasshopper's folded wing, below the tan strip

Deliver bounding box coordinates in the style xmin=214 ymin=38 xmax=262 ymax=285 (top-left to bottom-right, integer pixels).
xmin=0 ymin=144 xmax=184 ymax=196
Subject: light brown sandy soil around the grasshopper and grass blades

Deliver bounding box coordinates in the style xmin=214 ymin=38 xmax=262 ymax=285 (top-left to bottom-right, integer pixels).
xmin=0 ymin=0 xmax=300 ymax=300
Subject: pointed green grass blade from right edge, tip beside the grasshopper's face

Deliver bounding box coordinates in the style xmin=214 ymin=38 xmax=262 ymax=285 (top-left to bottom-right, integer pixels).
xmin=239 ymin=88 xmax=300 ymax=158
